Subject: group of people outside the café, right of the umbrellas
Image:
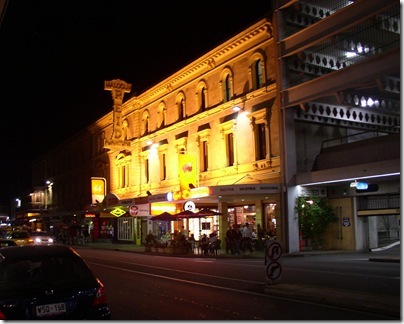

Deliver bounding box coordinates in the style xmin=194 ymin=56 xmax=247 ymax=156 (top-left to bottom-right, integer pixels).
xmin=226 ymin=223 xmax=264 ymax=255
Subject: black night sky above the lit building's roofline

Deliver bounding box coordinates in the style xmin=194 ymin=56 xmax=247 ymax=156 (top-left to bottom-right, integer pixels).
xmin=0 ymin=0 xmax=271 ymax=205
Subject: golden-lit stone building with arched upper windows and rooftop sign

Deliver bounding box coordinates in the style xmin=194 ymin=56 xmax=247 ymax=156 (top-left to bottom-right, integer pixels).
xmin=91 ymin=19 xmax=282 ymax=244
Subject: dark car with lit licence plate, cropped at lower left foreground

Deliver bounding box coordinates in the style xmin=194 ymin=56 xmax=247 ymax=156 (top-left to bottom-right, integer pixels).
xmin=0 ymin=245 xmax=111 ymax=320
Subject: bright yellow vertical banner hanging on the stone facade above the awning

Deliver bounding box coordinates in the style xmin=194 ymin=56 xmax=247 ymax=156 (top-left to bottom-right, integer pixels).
xmin=178 ymin=154 xmax=198 ymax=199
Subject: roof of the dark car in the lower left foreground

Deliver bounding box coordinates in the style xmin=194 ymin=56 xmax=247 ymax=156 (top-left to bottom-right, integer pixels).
xmin=0 ymin=245 xmax=78 ymax=260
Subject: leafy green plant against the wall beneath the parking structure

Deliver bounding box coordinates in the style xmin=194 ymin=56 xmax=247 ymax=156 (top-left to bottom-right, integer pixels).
xmin=295 ymin=196 xmax=338 ymax=249
